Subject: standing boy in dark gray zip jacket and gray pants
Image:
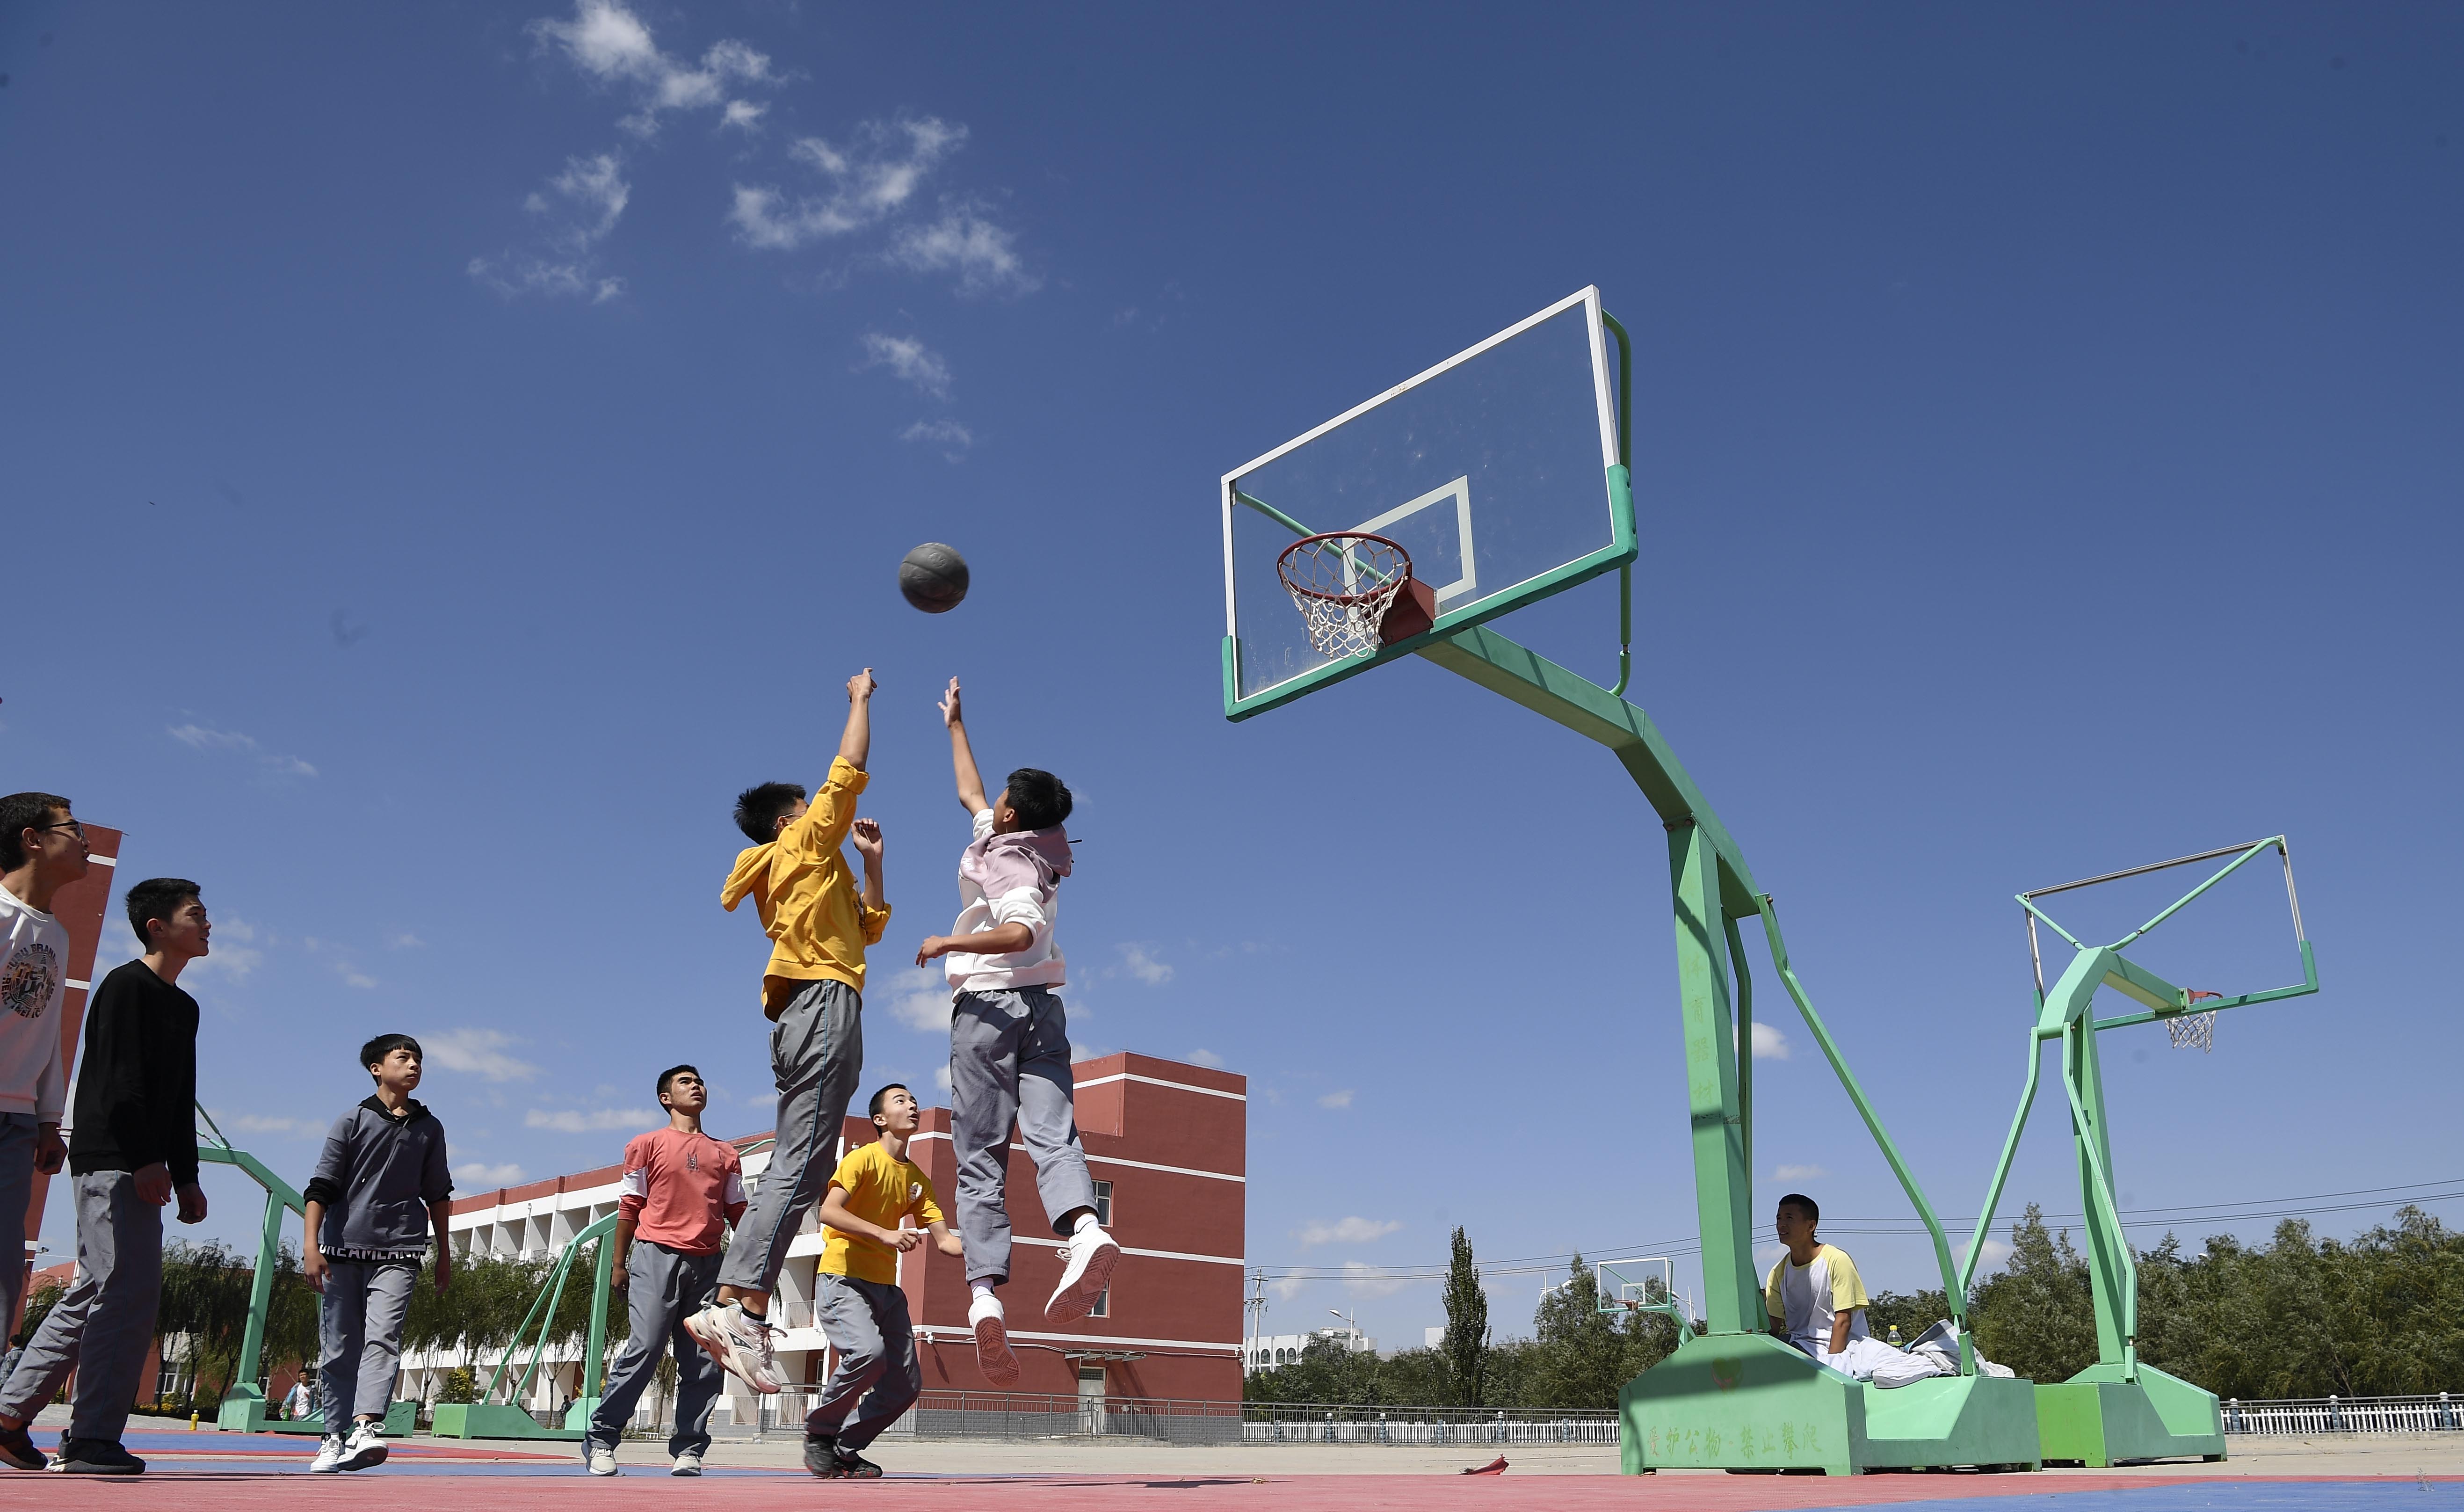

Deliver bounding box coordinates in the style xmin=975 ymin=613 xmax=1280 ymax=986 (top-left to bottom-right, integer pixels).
xmin=301 ymin=1034 xmax=453 ymax=1475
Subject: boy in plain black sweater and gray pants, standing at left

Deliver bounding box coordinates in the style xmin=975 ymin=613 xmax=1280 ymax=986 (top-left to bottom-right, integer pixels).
xmin=0 ymin=877 xmax=212 ymax=1475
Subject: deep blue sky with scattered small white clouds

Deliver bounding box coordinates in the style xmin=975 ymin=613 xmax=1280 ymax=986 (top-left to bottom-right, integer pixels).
xmin=0 ymin=0 xmax=2464 ymax=1342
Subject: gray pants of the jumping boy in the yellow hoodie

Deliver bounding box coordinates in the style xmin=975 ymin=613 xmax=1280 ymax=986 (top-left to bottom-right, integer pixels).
xmin=719 ymin=980 xmax=865 ymax=1293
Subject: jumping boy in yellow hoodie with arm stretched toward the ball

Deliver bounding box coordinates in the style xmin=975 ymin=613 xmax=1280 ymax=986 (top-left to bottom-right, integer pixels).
xmin=685 ymin=668 xmax=890 ymax=1391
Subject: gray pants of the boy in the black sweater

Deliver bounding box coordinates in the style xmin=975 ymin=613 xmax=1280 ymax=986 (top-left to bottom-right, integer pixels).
xmin=0 ymin=1170 xmax=163 ymax=1443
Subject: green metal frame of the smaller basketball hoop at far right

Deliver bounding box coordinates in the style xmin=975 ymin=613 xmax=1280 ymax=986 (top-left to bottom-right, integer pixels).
xmin=1959 ymin=835 xmax=2319 ymax=1465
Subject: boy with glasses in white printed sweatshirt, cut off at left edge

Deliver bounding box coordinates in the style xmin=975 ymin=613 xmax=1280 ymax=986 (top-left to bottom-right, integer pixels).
xmin=0 ymin=793 xmax=91 ymax=1438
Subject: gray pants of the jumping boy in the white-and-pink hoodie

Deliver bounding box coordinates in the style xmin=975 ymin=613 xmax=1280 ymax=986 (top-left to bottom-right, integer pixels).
xmin=949 ymin=988 xmax=1094 ymax=1286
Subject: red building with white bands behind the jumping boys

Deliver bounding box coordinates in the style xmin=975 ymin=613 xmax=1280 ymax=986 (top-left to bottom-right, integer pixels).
xmin=428 ymin=1054 xmax=1249 ymax=1416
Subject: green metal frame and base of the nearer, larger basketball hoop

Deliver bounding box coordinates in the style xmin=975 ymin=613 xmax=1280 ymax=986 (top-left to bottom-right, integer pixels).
xmin=1225 ymin=301 xmax=2038 ymax=1473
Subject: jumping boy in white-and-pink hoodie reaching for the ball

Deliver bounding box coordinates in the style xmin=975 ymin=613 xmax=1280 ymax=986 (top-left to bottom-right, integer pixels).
xmin=917 ymin=677 xmax=1121 ymax=1387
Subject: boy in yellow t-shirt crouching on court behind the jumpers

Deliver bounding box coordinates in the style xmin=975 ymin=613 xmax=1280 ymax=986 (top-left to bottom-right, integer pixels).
xmin=803 ymin=1081 xmax=961 ymax=1480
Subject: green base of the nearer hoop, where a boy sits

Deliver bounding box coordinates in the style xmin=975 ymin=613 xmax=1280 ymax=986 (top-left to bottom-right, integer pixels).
xmin=1616 ymin=1335 xmax=2038 ymax=1475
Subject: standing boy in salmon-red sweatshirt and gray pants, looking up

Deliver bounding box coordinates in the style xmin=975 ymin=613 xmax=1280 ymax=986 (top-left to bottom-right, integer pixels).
xmin=587 ymin=1066 xmax=744 ymax=1475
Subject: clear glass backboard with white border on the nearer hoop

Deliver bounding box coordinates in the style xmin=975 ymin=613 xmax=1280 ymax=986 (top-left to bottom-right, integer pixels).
xmin=1222 ymin=288 xmax=1634 ymax=719
